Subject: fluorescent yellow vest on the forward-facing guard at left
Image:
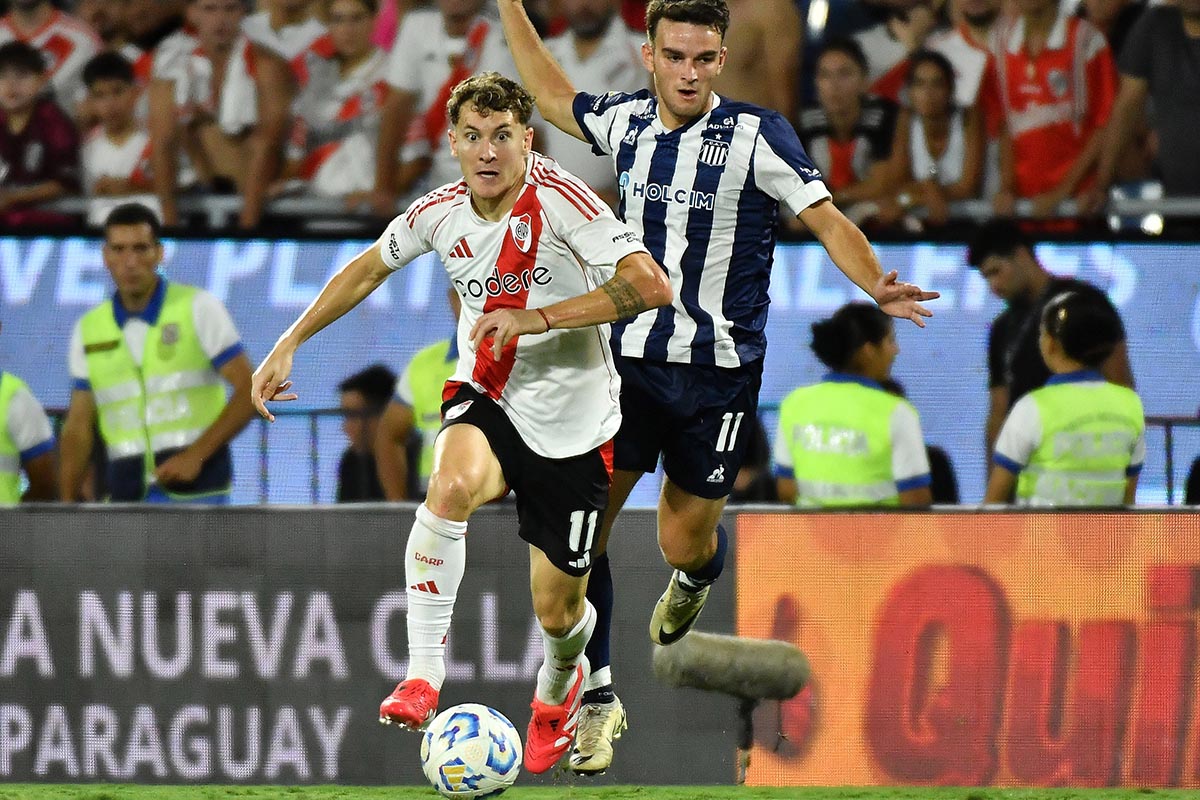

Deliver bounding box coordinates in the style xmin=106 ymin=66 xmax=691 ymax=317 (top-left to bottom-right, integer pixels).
xmin=80 ymin=283 xmax=228 ymax=493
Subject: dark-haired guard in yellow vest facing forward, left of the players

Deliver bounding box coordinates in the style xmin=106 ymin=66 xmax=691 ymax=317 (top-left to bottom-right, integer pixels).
xmin=59 ymin=203 xmax=253 ymax=504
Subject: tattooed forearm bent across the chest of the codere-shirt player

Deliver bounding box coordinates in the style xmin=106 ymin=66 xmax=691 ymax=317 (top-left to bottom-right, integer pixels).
xmin=470 ymin=253 xmax=673 ymax=359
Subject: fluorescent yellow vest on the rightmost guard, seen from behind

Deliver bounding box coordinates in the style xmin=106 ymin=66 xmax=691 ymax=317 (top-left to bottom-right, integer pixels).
xmin=1016 ymin=375 xmax=1146 ymax=506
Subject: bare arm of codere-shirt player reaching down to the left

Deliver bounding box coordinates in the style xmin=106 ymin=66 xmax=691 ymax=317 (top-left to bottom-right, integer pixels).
xmin=250 ymin=242 xmax=391 ymax=422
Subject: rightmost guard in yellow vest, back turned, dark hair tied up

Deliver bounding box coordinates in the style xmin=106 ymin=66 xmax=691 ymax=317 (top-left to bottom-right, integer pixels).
xmin=985 ymin=291 xmax=1146 ymax=506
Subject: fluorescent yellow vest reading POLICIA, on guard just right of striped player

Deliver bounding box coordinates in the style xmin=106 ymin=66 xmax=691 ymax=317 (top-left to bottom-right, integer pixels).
xmin=779 ymin=379 xmax=907 ymax=507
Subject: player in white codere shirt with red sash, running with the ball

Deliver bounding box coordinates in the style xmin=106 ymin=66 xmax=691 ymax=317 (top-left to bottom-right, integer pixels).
xmin=252 ymin=73 xmax=671 ymax=772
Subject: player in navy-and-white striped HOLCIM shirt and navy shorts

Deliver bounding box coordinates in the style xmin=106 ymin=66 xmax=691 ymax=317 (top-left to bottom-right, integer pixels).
xmin=499 ymin=0 xmax=937 ymax=774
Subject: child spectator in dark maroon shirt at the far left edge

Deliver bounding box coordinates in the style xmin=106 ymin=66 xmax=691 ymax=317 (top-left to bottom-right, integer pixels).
xmin=0 ymin=42 xmax=79 ymax=229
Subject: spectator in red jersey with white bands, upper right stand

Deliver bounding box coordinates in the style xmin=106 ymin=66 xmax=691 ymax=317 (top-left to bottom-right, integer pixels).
xmin=995 ymin=0 xmax=1117 ymax=217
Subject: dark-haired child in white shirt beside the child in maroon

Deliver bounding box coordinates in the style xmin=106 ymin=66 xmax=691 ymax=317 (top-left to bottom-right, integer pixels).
xmin=83 ymin=53 xmax=162 ymax=227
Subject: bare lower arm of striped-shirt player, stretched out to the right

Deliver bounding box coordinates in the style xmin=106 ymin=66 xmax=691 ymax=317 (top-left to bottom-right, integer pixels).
xmin=799 ymin=200 xmax=941 ymax=327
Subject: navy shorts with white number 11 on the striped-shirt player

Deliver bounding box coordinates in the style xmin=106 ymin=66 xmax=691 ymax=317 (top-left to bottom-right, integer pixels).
xmin=613 ymin=356 xmax=762 ymax=499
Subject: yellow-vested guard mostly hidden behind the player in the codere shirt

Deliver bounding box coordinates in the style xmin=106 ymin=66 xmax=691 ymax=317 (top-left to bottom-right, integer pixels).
xmin=376 ymin=288 xmax=462 ymax=500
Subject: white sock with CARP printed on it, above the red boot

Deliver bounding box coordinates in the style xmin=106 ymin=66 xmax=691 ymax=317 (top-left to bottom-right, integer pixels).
xmin=404 ymin=504 xmax=467 ymax=690
